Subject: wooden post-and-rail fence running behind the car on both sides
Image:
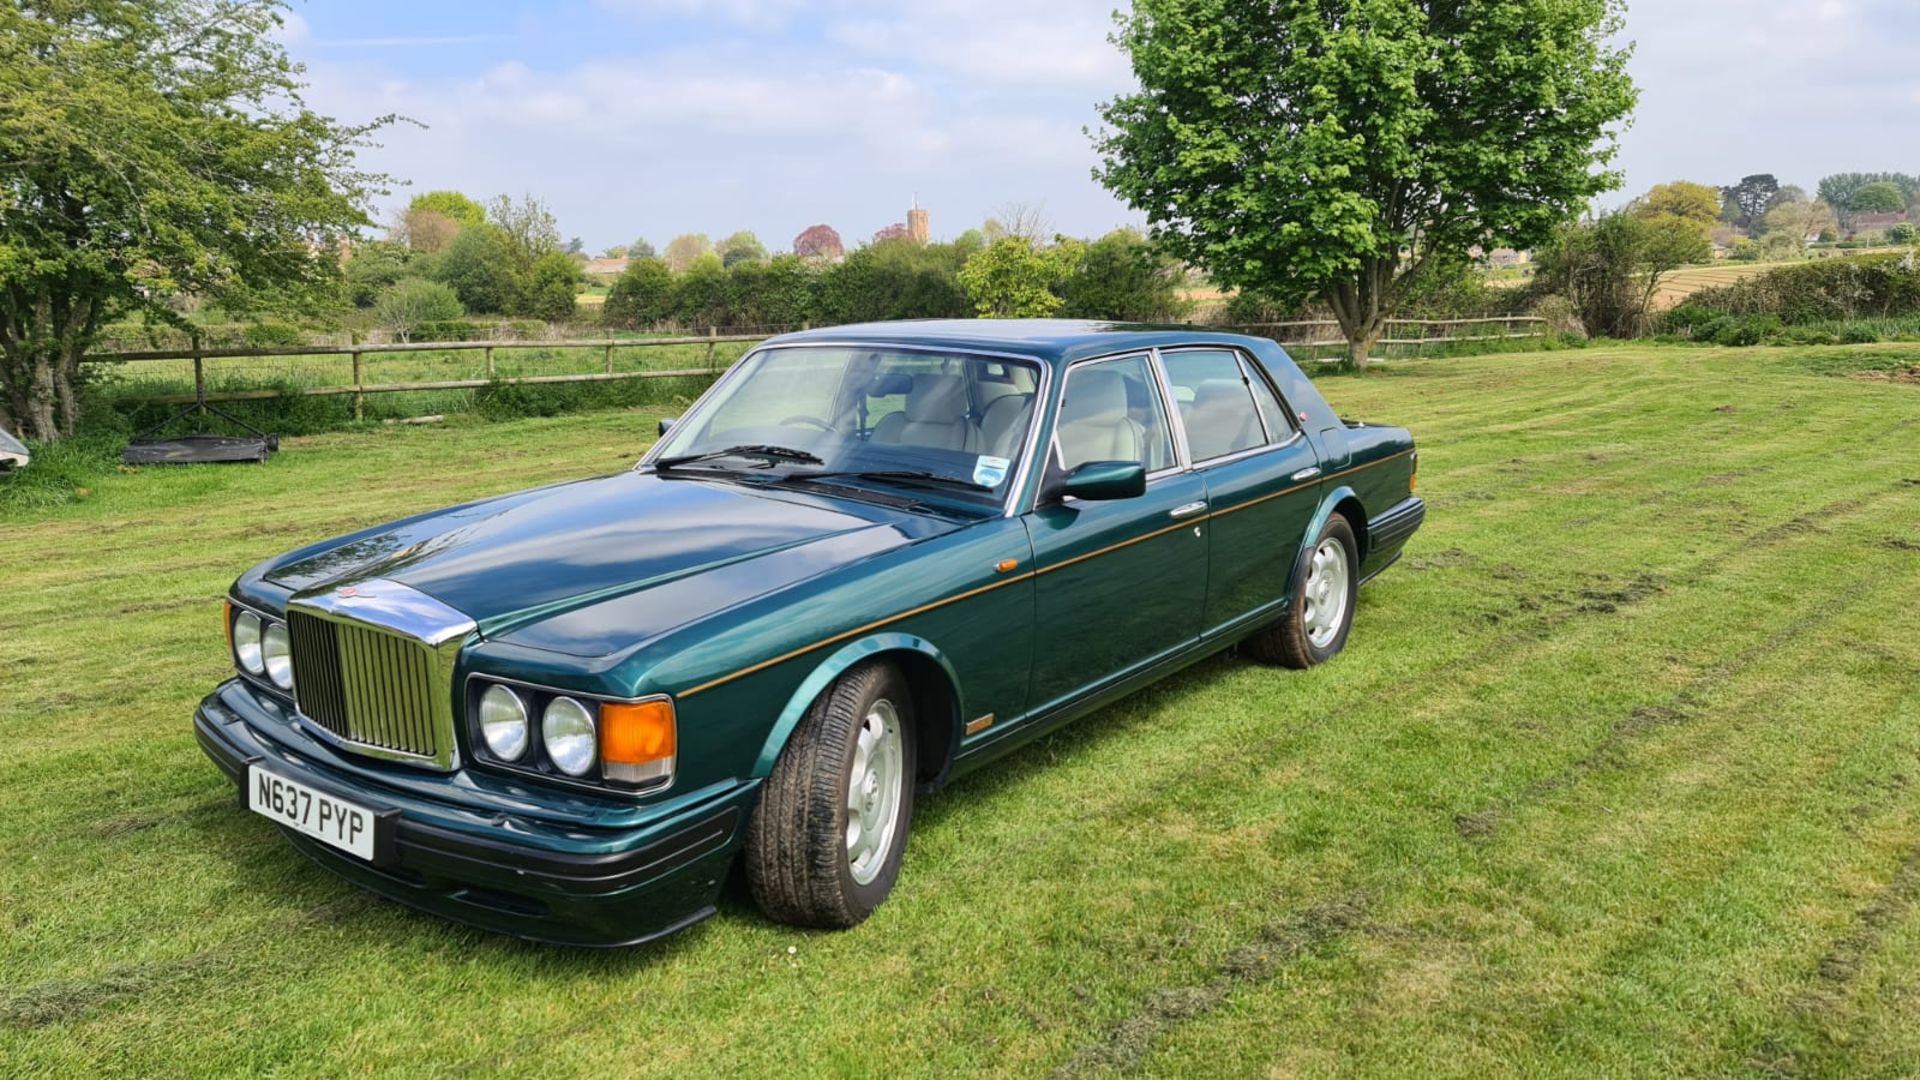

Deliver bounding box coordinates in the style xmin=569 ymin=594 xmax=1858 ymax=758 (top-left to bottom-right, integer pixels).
xmin=86 ymin=315 xmax=1546 ymax=419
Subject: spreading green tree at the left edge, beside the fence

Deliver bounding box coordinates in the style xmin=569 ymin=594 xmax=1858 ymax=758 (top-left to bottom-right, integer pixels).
xmin=0 ymin=0 xmax=386 ymax=440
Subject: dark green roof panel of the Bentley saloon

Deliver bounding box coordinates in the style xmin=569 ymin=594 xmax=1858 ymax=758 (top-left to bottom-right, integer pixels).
xmin=766 ymin=319 xmax=1273 ymax=365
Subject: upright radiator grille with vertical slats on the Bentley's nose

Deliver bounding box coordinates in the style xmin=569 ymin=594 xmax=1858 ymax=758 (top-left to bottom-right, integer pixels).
xmin=286 ymin=607 xmax=453 ymax=761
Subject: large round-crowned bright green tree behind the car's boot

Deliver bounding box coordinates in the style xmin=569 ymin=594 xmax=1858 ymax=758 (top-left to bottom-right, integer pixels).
xmin=1096 ymin=0 xmax=1636 ymax=365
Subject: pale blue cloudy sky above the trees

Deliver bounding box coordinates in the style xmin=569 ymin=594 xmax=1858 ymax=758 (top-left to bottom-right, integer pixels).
xmin=286 ymin=0 xmax=1920 ymax=252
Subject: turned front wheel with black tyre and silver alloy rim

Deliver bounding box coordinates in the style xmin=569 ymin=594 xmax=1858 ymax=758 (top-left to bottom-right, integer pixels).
xmin=745 ymin=663 xmax=916 ymax=928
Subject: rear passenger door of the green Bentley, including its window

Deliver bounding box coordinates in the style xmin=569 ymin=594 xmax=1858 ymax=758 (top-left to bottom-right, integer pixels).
xmin=1160 ymin=346 xmax=1319 ymax=636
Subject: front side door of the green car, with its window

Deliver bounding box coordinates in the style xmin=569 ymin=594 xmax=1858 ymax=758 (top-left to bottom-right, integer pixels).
xmin=1027 ymin=354 xmax=1208 ymax=715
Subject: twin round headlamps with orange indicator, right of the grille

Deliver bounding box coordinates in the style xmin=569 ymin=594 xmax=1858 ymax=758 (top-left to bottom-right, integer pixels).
xmin=467 ymin=678 xmax=680 ymax=788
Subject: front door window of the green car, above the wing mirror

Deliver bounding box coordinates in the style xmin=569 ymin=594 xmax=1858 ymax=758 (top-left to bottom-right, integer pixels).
xmin=1054 ymin=356 xmax=1173 ymax=473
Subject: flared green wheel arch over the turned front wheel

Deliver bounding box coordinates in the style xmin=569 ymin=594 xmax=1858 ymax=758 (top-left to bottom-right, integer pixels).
xmin=753 ymin=634 xmax=960 ymax=784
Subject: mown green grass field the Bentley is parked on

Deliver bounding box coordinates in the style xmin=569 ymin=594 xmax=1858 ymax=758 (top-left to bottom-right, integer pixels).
xmin=0 ymin=346 xmax=1920 ymax=1076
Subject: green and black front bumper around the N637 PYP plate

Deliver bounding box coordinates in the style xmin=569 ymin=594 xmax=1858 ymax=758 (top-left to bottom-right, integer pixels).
xmin=194 ymin=680 xmax=758 ymax=947
